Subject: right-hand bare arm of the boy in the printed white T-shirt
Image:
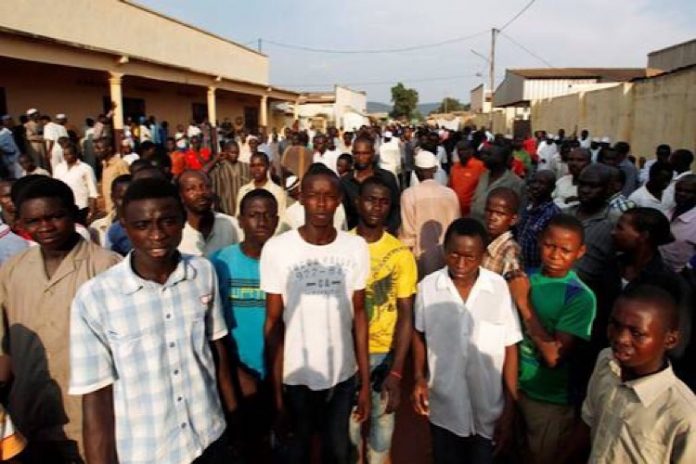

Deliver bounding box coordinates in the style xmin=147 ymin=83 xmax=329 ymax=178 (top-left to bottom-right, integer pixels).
xmin=353 ymin=289 xmax=371 ymax=422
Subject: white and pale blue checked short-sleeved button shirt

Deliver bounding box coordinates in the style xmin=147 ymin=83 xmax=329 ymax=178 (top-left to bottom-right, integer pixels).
xmin=70 ymin=254 xmax=227 ymax=464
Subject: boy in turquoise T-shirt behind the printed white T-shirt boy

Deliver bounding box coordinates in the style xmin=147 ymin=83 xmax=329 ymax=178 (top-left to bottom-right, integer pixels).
xmin=210 ymin=189 xmax=278 ymax=462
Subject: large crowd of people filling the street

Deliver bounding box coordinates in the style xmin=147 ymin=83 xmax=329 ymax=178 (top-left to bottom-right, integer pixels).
xmin=0 ymin=108 xmax=696 ymax=464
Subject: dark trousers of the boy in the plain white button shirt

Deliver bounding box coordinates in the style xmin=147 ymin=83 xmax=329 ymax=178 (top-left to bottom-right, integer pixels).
xmin=430 ymin=422 xmax=493 ymax=464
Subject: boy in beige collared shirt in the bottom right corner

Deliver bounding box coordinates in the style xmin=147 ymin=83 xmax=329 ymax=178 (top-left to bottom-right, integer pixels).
xmin=569 ymin=285 xmax=696 ymax=463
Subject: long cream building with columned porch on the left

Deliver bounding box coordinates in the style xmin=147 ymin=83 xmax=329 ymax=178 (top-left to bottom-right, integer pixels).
xmin=0 ymin=0 xmax=299 ymax=144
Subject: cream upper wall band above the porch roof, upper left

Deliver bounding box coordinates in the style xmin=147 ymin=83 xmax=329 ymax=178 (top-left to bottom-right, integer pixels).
xmin=0 ymin=0 xmax=268 ymax=84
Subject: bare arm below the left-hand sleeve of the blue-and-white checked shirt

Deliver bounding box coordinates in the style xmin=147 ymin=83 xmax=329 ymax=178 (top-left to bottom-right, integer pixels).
xmin=82 ymin=385 xmax=118 ymax=464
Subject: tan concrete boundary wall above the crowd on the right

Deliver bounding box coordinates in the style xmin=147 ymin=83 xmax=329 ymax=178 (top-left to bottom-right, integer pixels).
xmin=532 ymin=67 xmax=696 ymax=157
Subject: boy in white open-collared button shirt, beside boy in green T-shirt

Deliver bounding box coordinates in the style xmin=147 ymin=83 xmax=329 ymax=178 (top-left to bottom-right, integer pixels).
xmin=413 ymin=218 xmax=522 ymax=463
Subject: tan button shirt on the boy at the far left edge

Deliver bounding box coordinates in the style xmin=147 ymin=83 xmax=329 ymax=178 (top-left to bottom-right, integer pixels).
xmin=0 ymin=240 xmax=120 ymax=443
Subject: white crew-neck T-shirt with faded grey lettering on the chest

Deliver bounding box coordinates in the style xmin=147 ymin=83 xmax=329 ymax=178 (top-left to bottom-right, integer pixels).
xmin=261 ymin=230 xmax=370 ymax=390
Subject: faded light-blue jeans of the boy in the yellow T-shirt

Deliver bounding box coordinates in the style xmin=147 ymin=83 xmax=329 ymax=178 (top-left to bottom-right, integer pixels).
xmin=350 ymin=353 xmax=394 ymax=464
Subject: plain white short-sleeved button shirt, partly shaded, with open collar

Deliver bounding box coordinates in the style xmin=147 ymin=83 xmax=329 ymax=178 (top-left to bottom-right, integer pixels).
xmin=415 ymin=267 xmax=522 ymax=439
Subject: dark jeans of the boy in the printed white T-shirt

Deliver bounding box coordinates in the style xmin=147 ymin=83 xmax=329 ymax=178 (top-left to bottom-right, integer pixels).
xmin=284 ymin=376 xmax=356 ymax=464
